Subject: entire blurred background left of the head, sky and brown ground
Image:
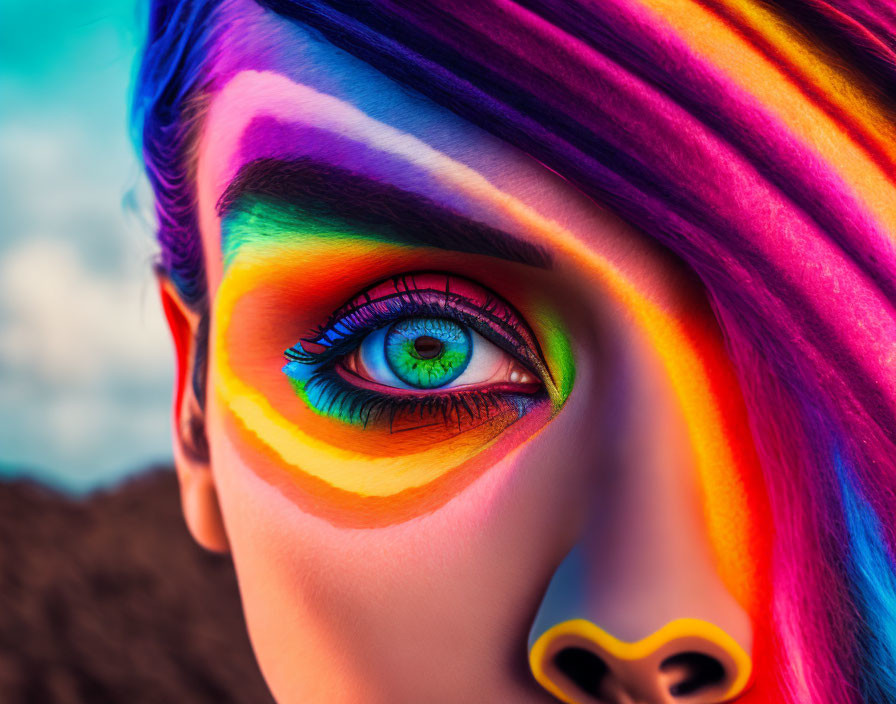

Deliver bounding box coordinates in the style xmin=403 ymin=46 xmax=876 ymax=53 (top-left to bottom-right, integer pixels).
xmin=0 ymin=0 xmax=270 ymax=704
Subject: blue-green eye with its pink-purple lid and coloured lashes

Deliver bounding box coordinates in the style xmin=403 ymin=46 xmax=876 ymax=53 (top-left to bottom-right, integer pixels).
xmin=282 ymin=272 xmax=550 ymax=432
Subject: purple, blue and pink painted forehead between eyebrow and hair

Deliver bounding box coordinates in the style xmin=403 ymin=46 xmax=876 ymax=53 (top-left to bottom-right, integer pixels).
xmin=196 ymin=3 xmax=688 ymax=296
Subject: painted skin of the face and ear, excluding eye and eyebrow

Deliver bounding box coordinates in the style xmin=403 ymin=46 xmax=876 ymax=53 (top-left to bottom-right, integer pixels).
xmin=161 ymin=2 xmax=774 ymax=704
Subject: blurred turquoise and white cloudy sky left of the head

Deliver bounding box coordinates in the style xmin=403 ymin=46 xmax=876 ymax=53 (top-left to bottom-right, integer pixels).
xmin=0 ymin=0 xmax=173 ymax=492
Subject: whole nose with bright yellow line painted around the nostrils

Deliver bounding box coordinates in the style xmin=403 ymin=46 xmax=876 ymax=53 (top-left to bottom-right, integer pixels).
xmin=529 ymin=344 xmax=752 ymax=704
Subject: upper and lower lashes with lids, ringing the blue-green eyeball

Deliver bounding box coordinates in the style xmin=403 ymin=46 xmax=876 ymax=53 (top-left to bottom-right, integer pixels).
xmin=284 ymin=275 xmax=546 ymax=432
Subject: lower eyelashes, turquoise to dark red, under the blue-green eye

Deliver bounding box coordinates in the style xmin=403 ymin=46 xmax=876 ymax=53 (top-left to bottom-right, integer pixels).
xmin=300 ymin=365 xmax=545 ymax=433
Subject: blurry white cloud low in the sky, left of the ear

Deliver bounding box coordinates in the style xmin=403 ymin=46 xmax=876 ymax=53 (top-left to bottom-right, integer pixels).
xmin=0 ymin=238 xmax=169 ymax=388
